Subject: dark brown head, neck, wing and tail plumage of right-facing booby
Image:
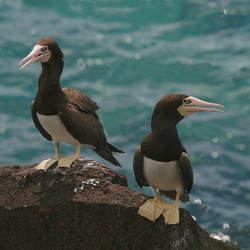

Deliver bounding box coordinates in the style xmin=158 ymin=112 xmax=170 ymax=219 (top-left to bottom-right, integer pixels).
xmin=133 ymin=94 xmax=193 ymax=203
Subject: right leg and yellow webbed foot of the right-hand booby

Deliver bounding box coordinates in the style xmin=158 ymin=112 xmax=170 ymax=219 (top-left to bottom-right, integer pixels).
xmin=162 ymin=192 xmax=181 ymax=225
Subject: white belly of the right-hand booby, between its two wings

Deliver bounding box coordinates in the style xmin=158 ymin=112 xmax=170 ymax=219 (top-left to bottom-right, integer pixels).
xmin=143 ymin=156 xmax=184 ymax=193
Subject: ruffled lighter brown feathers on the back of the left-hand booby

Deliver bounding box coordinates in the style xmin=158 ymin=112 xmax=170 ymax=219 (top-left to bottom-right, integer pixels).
xmin=62 ymin=88 xmax=99 ymax=117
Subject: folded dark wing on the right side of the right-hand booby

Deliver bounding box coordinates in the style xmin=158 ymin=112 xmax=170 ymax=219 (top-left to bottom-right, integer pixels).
xmin=178 ymin=152 xmax=194 ymax=193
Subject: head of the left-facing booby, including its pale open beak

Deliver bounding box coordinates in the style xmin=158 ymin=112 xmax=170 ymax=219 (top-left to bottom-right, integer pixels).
xmin=19 ymin=37 xmax=63 ymax=69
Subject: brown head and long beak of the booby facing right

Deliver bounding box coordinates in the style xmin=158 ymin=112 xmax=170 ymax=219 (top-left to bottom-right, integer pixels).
xmin=152 ymin=94 xmax=224 ymax=128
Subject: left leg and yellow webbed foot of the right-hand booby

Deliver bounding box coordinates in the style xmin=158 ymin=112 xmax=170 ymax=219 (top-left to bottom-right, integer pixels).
xmin=138 ymin=187 xmax=168 ymax=221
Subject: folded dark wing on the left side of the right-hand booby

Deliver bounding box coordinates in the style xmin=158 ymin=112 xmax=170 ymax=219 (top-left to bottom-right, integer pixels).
xmin=133 ymin=146 xmax=148 ymax=187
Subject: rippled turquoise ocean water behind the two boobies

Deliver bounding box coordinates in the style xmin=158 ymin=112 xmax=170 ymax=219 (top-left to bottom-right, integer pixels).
xmin=0 ymin=0 xmax=250 ymax=249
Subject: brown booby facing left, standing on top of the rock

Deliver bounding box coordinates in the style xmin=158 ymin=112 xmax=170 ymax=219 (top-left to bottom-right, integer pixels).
xmin=20 ymin=37 xmax=124 ymax=170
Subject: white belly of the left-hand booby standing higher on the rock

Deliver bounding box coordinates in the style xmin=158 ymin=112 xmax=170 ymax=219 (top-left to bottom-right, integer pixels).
xmin=37 ymin=113 xmax=79 ymax=145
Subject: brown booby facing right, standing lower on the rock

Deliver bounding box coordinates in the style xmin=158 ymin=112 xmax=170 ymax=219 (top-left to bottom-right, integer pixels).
xmin=133 ymin=94 xmax=224 ymax=224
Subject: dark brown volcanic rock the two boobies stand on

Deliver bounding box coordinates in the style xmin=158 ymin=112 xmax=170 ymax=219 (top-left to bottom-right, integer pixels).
xmin=0 ymin=159 xmax=238 ymax=250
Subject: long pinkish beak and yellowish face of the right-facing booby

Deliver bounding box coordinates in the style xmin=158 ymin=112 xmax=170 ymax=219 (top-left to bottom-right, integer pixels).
xmin=177 ymin=96 xmax=224 ymax=116
